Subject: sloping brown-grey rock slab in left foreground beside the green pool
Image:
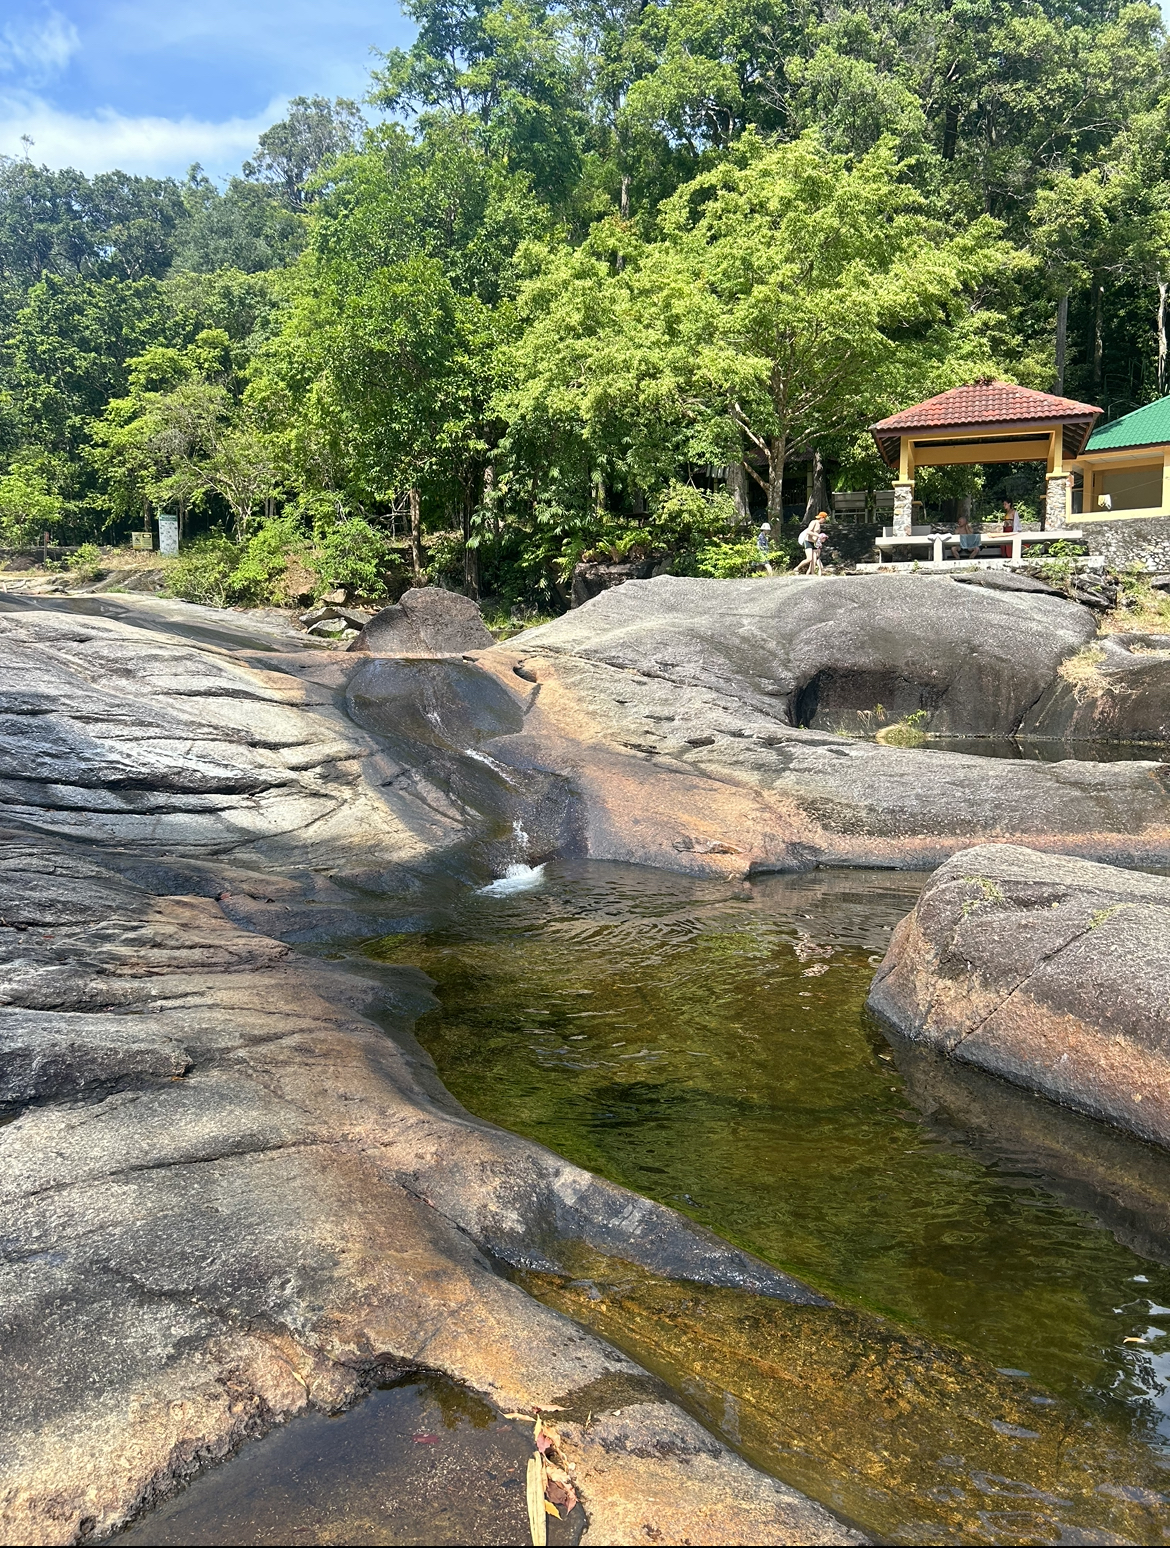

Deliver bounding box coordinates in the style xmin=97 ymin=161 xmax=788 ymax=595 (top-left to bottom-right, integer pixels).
xmin=0 ymin=834 xmax=859 ymax=1543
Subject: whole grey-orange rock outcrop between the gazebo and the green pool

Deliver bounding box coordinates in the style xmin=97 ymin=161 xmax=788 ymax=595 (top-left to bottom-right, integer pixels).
xmin=458 ymin=576 xmax=1170 ymax=876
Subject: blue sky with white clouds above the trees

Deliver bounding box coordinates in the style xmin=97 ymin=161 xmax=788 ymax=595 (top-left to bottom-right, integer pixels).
xmin=0 ymin=0 xmax=413 ymax=176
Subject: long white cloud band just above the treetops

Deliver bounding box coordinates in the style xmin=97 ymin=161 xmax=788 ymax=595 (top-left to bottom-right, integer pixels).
xmin=0 ymin=93 xmax=285 ymax=176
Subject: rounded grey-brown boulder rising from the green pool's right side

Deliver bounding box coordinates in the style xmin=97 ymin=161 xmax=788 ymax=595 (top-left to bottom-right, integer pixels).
xmin=868 ymin=844 xmax=1170 ymax=1146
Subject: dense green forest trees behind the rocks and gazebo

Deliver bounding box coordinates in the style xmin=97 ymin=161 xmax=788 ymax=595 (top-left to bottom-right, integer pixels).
xmin=0 ymin=0 xmax=1170 ymax=607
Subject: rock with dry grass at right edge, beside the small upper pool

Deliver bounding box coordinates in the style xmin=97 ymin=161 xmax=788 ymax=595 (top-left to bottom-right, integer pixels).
xmin=1020 ymin=633 xmax=1170 ymax=743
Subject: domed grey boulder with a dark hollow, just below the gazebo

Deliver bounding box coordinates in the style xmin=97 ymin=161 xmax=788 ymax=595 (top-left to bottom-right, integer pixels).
xmin=514 ymin=574 xmax=1096 ymax=737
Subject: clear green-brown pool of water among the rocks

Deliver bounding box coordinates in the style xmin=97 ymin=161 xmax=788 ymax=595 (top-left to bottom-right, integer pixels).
xmin=365 ymin=864 xmax=1170 ymax=1542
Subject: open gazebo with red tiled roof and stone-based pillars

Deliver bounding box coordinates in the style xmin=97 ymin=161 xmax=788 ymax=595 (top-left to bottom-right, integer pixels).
xmin=870 ymin=381 xmax=1102 ymax=537
